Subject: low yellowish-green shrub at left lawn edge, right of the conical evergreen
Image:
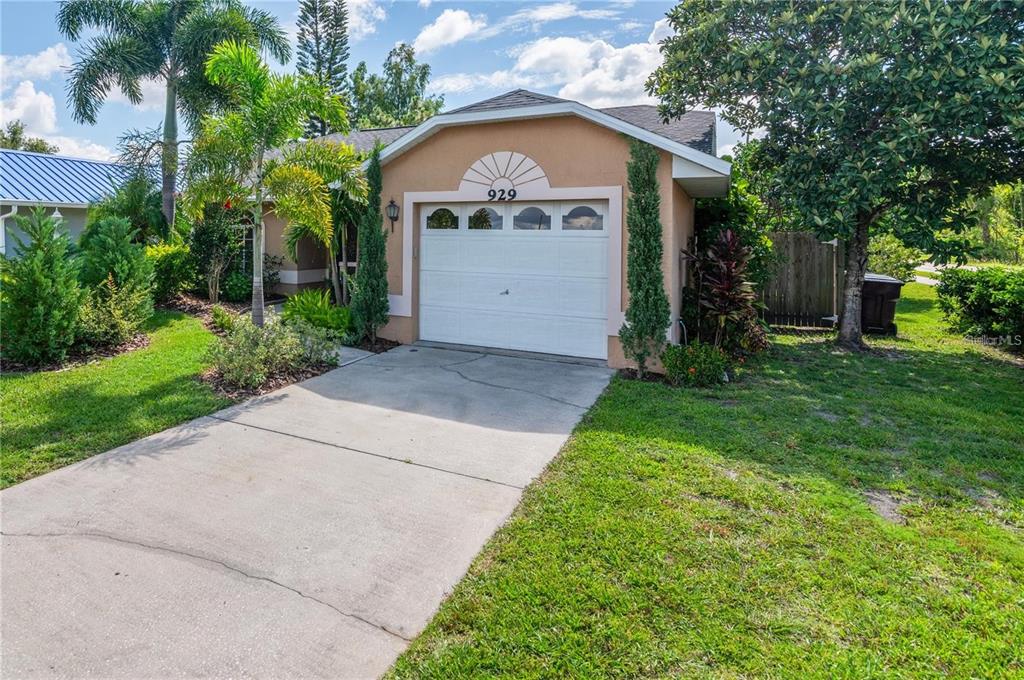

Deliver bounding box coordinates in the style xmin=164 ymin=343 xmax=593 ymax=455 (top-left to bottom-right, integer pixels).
xmin=78 ymin=274 xmax=153 ymax=348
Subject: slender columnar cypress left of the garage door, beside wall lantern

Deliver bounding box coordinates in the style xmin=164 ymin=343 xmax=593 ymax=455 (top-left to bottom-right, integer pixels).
xmin=351 ymin=147 xmax=388 ymax=343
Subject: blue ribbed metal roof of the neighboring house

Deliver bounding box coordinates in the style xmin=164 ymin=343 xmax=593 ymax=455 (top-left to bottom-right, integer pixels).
xmin=0 ymin=148 xmax=127 ymax=205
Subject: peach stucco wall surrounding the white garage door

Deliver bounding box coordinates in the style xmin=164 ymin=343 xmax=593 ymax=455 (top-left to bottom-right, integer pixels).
xmin=284 ymin=117 xmax=692 ymax=368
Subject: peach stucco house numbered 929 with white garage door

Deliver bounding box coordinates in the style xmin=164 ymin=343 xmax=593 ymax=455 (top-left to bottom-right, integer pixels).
xmin=267 ymin=90 xmax=730 ymax=368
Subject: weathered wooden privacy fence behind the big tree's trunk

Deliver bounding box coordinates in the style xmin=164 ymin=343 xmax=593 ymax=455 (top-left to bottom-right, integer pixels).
xmin=762 ymin=231 xmax=846 ymax=328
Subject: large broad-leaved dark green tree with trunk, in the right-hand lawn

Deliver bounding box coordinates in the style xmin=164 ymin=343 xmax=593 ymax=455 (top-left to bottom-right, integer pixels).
xmin=648 ymin=0 xmax=1024 ymax=348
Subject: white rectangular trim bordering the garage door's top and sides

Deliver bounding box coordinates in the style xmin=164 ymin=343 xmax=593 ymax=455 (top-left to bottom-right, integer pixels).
xmin=388 ymin=184 xmax=626 ymax=336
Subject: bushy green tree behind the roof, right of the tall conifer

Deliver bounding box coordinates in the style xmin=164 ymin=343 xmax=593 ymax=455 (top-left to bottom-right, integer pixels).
xmin=349 ymin=43 xmax=444 ymax=129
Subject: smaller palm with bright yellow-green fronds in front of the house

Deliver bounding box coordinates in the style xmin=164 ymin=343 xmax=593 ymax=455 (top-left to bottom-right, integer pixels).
xmin=183 ymin=41 xmax=347 ymax=326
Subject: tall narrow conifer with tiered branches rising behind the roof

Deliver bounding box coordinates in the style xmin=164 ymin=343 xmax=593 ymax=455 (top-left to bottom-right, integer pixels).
xmin=296 ymin=0 xmax=348 ymax=137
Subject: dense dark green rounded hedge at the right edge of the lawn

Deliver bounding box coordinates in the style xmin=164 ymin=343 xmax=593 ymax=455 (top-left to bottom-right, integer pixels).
xmin=938 ymin=266 xmax=1024 ymax=346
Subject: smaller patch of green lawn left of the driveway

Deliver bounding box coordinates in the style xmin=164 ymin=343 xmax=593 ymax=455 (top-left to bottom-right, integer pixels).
xmin=0 ymin=311 xmax=228 ymax=487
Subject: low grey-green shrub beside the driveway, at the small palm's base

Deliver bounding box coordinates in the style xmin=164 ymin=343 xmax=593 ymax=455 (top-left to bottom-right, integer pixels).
xmin=209 ymin=316 xmax=337 ymax=389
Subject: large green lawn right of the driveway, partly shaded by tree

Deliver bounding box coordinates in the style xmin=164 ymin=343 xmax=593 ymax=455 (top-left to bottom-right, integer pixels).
xmin=391 ymin=284 xmax=1024 ymax=679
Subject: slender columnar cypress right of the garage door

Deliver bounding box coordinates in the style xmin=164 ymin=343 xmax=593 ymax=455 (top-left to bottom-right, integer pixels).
xmin=618 ymin=139 xmax=669 ymax=378
